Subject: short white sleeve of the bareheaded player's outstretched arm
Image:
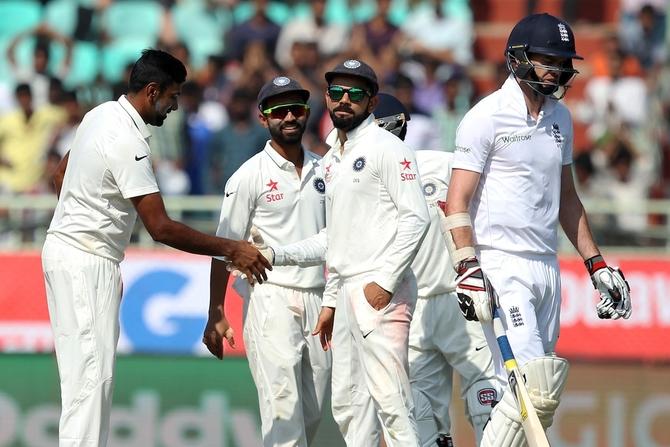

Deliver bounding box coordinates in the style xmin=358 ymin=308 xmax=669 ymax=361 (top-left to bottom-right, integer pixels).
xmin=105 ymin=135 xmax=159 ymax=199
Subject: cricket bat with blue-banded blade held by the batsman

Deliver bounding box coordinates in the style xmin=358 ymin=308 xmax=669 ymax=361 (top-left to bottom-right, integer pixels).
xmin=493 ymin=307 xmax=550 ymax=447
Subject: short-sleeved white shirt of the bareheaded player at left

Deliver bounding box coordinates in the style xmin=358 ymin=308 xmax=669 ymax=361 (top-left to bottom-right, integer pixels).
xmin=47 ymin=96 xmax=158 ymax=262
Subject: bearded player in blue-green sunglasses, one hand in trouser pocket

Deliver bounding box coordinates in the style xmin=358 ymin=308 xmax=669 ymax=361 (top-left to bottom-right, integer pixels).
xmin=242 ymin=59 xmax=429 ymax=447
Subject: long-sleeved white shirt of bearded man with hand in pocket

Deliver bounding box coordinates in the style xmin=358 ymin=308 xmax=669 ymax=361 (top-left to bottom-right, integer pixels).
xmin=323 ymin=115 xmax=430 ymax=306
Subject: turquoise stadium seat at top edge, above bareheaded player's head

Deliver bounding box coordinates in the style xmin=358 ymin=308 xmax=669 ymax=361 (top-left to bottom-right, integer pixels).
xmin=102 ymin=0 xmax=163 ymax=41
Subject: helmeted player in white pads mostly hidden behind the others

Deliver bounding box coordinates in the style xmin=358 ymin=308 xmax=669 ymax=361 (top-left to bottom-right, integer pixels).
xmin=374 ymin=93 xmax=500 ymax=447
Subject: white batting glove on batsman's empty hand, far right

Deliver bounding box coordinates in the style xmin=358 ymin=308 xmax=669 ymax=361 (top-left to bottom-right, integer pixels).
xmin=584 ymin=255 xmax=633 ymax=320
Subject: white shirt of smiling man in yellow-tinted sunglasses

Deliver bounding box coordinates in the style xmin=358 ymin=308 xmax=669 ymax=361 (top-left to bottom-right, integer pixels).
xmin=216 ymin=141 xmax=326 ymax=289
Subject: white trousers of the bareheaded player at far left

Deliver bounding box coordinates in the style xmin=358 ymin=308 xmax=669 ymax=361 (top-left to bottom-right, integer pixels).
xmin=42 ymin=236 xmax=122 ymax=447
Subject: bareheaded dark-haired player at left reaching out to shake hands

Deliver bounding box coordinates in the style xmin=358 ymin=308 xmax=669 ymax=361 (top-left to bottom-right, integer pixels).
xmin=42 ymin=50 xmax=271 ymax=447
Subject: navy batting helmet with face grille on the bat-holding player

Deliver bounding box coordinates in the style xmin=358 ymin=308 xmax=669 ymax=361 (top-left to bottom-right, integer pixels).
xmin=505 ymin=13 xmax=584 ymax=99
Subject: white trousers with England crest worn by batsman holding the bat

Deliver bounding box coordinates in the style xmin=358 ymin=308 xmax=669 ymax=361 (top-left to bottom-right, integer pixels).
xmin=480 ymin=250 xmax=561 ymax=387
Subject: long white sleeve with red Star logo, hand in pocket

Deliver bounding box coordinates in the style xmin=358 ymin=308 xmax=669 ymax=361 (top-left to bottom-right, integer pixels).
xmin=374 ymin=141 xmax=430 ymax=293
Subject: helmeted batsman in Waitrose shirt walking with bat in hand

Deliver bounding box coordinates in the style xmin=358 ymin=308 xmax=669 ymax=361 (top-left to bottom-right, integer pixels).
xmin=443 ymin=14 xmax=631 ymax=447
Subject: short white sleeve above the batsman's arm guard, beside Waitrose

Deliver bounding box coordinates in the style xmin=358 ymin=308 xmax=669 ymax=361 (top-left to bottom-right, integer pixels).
xmin=453 ymin=109 xmax=494 ymax=173
